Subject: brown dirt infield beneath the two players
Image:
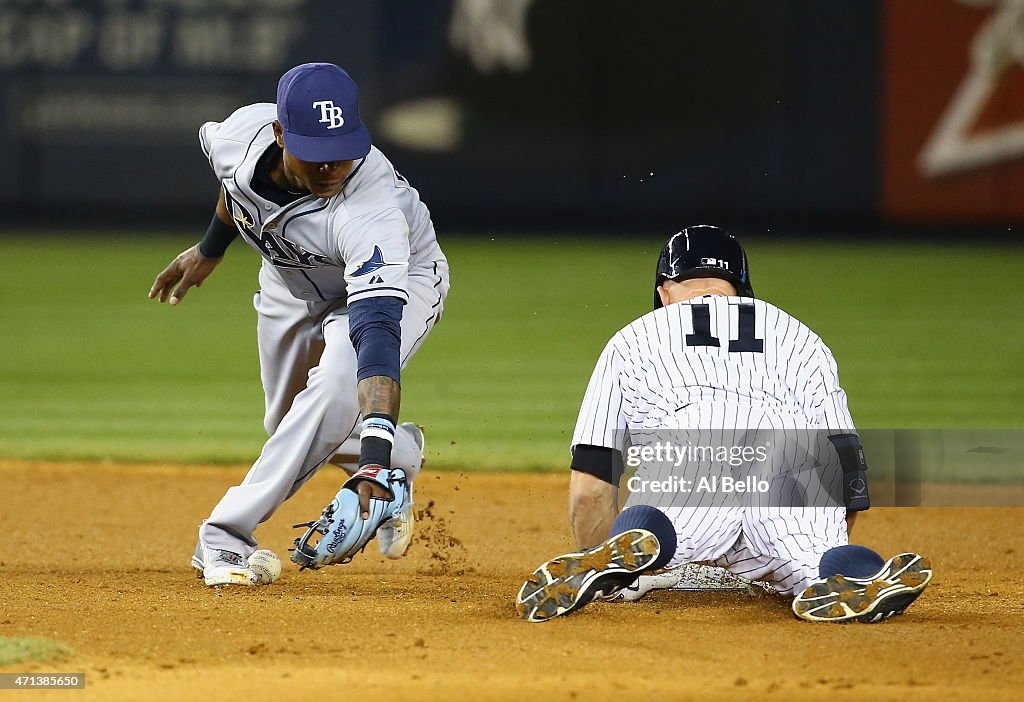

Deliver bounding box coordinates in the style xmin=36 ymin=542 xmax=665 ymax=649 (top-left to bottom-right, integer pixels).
xmin=0 ymin=462 xmax=1024 ymax=702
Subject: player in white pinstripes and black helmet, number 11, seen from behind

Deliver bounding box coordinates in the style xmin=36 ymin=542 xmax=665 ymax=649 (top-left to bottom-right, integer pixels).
xmin=516 ymin=225 xmax=932 ymax=622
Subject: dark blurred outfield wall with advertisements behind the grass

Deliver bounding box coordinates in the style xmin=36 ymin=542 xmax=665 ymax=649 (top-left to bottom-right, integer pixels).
xmin=0 ymin=0 xmax=1024 ymax=228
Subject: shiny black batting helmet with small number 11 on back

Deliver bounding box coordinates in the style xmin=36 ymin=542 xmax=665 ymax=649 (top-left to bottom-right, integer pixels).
xmin=654 ymin=224 xmax=754 ymax=309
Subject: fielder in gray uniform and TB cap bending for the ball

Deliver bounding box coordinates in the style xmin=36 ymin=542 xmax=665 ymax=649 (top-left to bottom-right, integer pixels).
xmin=150 ymin=63 xmax=449 ymax=586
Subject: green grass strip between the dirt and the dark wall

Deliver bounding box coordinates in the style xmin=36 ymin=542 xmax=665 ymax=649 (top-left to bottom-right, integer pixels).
xmin=0 ymin=233 xmax=1024 ymax=470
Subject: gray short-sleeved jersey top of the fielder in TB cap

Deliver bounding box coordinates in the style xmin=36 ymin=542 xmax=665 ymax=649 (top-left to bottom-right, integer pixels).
xmin=200 ymin=102 xmax=446 ymax=302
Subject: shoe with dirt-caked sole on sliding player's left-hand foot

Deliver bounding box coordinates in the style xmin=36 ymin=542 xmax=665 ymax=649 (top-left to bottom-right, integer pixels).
xmin=515 ymin=529 xmax=660 ymax=622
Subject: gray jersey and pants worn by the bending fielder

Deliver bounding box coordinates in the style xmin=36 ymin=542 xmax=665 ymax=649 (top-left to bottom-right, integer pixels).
xmin=194 ymin=103 xmax=449 ymax=564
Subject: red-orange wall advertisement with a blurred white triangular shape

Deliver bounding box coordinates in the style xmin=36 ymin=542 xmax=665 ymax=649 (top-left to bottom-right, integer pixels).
xmin=883 ymin=0 xmax=1024 ymax=222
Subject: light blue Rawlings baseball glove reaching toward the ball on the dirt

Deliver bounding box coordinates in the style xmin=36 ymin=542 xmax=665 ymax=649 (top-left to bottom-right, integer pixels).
xmin=292 ymin=466 xmax=409 ymax=570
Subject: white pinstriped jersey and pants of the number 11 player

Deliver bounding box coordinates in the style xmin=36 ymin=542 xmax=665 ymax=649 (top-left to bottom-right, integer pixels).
xmin=572 ymin=296 xmax=855 ymax=594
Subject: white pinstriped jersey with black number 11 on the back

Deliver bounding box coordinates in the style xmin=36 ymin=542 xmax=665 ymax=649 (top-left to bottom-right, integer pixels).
xmin=571 ymin=295 xmax=856 ymax=451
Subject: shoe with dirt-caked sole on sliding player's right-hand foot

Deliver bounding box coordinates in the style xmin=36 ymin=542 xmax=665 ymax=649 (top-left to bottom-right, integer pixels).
xmin=793 ymin=554 xmax=932 ymax=624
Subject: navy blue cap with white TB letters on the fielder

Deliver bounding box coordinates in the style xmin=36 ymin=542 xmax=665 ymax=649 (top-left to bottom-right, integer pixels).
xmin=278 ymin=63 xmax=370 ymax=163
